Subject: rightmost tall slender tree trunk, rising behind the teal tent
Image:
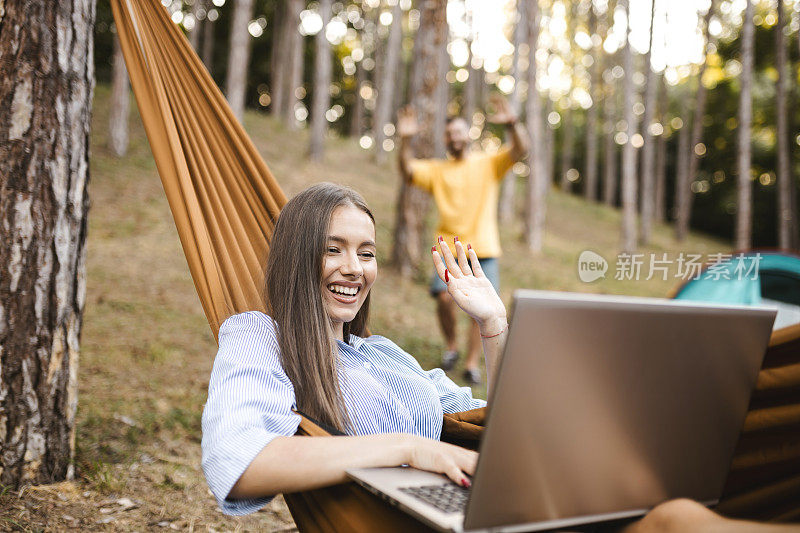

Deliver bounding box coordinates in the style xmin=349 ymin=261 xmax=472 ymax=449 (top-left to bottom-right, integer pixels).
xmin=774 ymin=0 xmax=797 ymax=250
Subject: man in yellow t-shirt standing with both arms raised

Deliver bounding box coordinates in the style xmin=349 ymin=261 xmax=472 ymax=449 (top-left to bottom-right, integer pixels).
xmin=397 ymin=95 xmax=528 ymax=385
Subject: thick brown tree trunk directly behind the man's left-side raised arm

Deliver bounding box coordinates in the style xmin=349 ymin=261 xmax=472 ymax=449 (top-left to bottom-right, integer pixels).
xmin=392 ymin=0 xmax=447 ymax=278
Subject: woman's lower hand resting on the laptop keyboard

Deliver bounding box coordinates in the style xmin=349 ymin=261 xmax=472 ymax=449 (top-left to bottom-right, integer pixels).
xmin=408 ymin=435 xmax=478 ymax=487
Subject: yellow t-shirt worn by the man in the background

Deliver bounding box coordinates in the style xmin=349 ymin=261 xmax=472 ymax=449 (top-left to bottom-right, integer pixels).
xmin=410 ymin=146 xmax=514 ymax=257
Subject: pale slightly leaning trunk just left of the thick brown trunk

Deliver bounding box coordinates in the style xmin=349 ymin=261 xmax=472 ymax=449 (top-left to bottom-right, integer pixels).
xmin=373 ymin=2 xmax=403 ymax=163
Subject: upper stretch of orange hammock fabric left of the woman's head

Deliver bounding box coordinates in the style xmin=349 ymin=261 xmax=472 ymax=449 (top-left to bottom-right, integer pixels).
xmin=111 ymin=0 xmax=286 ymax=339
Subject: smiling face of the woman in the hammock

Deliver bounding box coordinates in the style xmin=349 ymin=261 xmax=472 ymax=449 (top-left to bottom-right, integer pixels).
xmin=322 ymin=206 xmax=378 ymax=339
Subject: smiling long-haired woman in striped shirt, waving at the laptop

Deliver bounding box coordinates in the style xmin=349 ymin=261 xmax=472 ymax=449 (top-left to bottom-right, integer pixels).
xmin=202 ymin=183 xmax=508 ymax=515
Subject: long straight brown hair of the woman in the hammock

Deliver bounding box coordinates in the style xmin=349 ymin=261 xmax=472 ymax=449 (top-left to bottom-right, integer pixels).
xmin=264 ymin=183 xmax=375 ymax=432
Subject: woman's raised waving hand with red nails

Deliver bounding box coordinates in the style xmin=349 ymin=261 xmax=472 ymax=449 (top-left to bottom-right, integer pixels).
xmin=431 ymin=237 xmax=506 ymax=335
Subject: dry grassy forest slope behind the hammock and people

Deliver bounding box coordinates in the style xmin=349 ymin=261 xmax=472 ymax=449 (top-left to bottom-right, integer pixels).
xmin=0 ymin=86 xmax=729 ymax=531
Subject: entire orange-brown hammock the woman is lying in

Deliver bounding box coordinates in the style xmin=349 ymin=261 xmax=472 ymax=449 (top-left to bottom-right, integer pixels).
xmin=111 ymin=0 xmax=800 ymax=532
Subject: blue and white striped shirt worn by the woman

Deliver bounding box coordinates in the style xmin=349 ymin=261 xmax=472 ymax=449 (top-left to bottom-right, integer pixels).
xmin=202 ymin=311 xmax=486 ymax=515
